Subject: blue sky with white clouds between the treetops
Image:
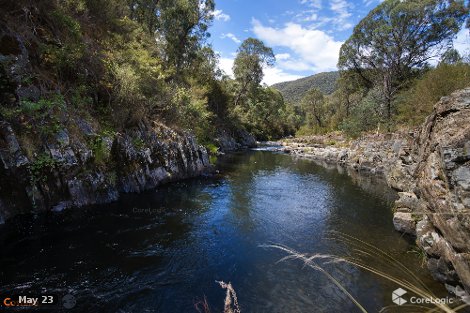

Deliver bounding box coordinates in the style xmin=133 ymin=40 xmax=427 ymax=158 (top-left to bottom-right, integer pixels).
xmin=209 ymin=0 xmax=470 ymax=85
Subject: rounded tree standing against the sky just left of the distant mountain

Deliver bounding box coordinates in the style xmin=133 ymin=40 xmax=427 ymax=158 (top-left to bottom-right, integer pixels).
xmin=233 ymin=38 xmax=276 ymax=106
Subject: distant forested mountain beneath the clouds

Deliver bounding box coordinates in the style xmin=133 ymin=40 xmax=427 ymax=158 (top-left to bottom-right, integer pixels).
xmin=272 ymin=72 xmax=339 ymax=103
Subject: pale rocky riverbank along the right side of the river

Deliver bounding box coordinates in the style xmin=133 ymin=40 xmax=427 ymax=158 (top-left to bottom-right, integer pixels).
xmin=282 ymin=88 xmax=470 ymax=296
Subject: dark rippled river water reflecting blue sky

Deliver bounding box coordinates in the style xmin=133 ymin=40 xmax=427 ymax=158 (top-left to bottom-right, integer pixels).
xmin=0 ymin=151 xmax=445 ymax=313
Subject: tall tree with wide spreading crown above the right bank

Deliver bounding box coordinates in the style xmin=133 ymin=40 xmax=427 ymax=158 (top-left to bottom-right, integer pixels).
xmin=338 ymin=0 xmax=468 ymax=125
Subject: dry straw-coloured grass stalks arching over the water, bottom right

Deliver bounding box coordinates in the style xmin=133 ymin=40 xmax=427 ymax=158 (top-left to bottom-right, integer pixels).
xmin=262 ymin=233 xmax=467 ymax=313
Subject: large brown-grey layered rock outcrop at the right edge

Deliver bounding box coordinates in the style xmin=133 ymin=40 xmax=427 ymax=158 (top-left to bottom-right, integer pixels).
xmin=413 ymin=89 xmax=470 ymax=292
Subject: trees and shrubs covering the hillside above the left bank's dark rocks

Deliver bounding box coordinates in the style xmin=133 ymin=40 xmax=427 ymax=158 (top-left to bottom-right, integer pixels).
xmin=0 ymin=0 xmax=302 ymax=147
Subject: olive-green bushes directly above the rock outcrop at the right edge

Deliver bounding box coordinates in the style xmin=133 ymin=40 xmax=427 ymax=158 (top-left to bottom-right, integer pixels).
xmin=397 ymin=63 xmax=470 ymax=126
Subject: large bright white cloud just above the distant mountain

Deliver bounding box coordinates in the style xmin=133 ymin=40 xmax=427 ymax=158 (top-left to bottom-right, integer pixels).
xmin=252 ymin=19 xmax=342 ymax=72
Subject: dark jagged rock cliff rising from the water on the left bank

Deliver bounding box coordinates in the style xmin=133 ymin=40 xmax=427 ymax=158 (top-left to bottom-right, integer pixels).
xmin=0 ymin=119 xmax=210 ymax=222
